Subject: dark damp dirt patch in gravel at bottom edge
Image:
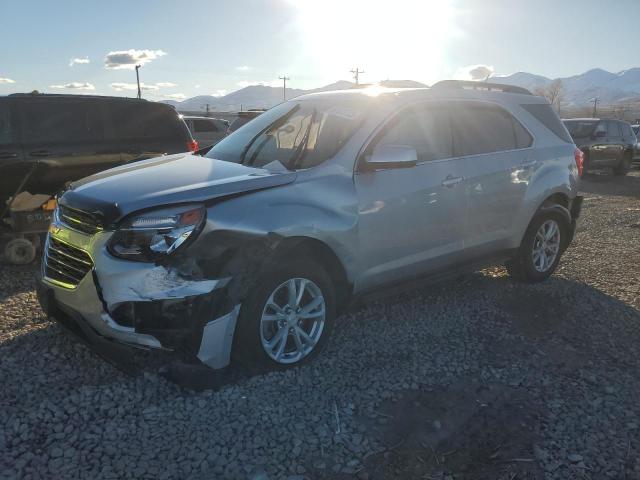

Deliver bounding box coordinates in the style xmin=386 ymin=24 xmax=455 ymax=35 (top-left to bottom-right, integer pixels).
xmin=360 ymin=384 xmax=543 ymax=480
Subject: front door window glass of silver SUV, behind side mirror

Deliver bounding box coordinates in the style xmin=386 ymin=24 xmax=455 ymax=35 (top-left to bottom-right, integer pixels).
xmin=375 ymin=105 xmax=453 ymax=162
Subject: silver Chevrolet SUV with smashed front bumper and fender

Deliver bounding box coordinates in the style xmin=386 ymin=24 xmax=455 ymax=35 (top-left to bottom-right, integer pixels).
xmin=38 ymin=81 xmax=582 ymax=368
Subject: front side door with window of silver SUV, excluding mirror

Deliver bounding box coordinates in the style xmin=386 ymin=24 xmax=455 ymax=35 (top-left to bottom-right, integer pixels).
xmin=355 ymin=103 xmax=466 ymax=289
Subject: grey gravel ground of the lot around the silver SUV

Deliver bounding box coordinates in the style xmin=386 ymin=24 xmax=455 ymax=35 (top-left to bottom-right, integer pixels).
xmin=0 ymin=171 xmax=640 ymax=480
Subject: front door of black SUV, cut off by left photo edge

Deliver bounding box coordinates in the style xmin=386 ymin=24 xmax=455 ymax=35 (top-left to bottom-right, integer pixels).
xmin=0 ymin=98 xmax=28 ymax=207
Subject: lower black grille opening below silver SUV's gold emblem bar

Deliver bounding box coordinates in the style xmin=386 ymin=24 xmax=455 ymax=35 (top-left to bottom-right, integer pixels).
xmin=44 ymin=236 xmax=93 ymax=287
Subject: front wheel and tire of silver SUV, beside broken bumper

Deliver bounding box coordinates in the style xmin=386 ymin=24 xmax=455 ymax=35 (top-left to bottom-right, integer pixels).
xmin=233 ymin=259 xmax=336 ymax=370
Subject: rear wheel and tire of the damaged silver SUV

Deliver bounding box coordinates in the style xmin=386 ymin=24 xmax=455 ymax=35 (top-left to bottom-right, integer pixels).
xmin=506 ymin=210 xmax=569 ymax=283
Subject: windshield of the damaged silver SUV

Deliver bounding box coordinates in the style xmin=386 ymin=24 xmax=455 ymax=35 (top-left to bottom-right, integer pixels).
xmin=207 ymin=101 xmax=365 ymax=170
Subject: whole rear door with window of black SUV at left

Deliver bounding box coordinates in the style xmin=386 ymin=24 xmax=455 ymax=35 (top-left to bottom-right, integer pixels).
xmin=20 ymin=97 xmax=120 ymax=194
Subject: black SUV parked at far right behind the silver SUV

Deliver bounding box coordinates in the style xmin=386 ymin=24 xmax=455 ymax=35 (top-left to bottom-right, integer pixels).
xmin=563 ymin=118 xmax=636 ymax=175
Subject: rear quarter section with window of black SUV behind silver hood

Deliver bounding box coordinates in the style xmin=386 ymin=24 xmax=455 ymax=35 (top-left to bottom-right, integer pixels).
xmin=109 ymin=100 xmax=191 ymax=163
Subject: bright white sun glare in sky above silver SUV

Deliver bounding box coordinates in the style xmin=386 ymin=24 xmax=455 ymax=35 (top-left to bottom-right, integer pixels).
xmin=290 ymin=0 xmax=455 ymax=83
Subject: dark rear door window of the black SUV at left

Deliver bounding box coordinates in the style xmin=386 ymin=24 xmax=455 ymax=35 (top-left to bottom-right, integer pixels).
xmin=22 ymin=100 xmax=104 ymax=143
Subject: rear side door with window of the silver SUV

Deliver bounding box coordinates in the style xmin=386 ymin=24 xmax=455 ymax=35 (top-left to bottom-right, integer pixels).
xmin=451 ymin=101 xmax=535 ymax=259
